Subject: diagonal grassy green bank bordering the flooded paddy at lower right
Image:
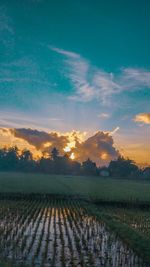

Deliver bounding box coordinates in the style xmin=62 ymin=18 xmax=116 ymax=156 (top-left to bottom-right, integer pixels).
xmin=85 ymin=205 xmax=150 ymax=266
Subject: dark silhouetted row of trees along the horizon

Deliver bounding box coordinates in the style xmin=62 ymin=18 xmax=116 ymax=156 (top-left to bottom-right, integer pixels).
xmin=0 ymin=146 xmax=150 ymax=178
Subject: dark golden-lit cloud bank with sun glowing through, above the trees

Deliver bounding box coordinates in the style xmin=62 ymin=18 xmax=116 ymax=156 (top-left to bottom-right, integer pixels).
xmin=0 ymin=128 xmax=119 ymax=166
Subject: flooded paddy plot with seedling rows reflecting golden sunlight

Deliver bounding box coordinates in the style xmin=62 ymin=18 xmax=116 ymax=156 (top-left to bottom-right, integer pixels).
xmin=0 ymin=200 xmax=146 ymax=267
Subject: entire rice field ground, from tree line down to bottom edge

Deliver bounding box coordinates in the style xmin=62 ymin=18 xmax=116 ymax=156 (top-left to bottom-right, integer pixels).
xmin=0 ymin=173 xmax=150 ymax=267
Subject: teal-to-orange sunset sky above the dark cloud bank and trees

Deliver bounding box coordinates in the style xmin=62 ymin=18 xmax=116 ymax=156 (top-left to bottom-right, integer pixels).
xmin=0 ymin=0 xmax=150 ymax=164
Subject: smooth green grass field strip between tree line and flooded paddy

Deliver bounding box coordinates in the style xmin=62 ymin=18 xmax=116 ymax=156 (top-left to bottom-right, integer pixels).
xmin=0 ymin=172 xmax=150 ymax=201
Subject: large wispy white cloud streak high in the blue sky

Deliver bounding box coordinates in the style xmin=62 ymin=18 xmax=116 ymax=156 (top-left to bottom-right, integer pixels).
xmin=49 ymin=47 xmax=150 ymax=104
